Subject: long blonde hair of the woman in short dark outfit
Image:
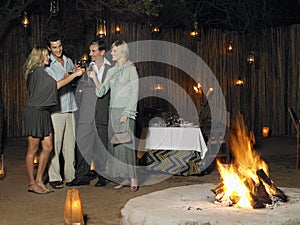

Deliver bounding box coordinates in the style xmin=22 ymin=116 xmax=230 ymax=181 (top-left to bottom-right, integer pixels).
xmin=23 ymin=47 xmax=48 ymax=80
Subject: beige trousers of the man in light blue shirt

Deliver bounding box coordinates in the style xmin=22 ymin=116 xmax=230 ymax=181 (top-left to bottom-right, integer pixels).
xmin=48 ymin=113 xmax=75 ymax=182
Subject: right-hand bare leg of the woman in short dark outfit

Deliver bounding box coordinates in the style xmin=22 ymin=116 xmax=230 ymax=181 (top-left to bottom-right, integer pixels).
xmin=35 ymin=134 xmax=53 ymax=192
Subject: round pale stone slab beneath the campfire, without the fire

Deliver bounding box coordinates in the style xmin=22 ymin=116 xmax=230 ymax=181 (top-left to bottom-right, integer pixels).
xmin=121 ymin=183 xmax=300 ymax=225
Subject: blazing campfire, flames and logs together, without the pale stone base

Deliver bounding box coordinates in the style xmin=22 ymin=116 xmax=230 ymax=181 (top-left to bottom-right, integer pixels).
xmin=211 ymin=114 xmax=288 ymax=209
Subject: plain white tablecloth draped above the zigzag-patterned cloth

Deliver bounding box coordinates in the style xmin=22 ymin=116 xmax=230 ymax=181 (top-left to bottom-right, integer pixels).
xmin=145 ymin=127 xmax=207 ymax=159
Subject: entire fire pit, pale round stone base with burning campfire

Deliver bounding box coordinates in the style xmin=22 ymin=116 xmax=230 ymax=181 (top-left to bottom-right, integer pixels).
xmin=122 ymin=115 xmax=300 ymax=225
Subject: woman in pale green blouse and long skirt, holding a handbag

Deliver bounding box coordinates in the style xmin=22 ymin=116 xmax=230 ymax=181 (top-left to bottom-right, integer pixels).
xmin=90 ymin=41 xmax=139 ymax=192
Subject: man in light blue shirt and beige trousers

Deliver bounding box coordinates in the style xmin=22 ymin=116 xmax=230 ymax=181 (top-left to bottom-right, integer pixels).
xmin=46 ymin=34 xmax=77 ymax=189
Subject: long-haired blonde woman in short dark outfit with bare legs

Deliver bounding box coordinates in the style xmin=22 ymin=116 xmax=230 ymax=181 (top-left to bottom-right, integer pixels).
xmin=22 ymin=47 xmax=84 ymax=194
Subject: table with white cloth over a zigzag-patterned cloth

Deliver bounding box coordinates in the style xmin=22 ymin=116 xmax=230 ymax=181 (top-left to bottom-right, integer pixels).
xmin=140 ymin=126 xmax=207 ymax=175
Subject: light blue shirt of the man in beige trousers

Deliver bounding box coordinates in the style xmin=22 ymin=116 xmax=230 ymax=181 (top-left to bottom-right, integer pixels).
xmin=45 ymin=54 xmax=77 ymax=113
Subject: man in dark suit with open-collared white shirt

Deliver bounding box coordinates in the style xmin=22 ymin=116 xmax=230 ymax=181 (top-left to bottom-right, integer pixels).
xmin=66 ymin=39 xmax=111 ymax=187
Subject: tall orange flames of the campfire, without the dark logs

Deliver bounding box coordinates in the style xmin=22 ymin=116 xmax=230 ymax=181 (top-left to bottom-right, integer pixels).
xmin=217 ymin=114 xmax=272 ymax=207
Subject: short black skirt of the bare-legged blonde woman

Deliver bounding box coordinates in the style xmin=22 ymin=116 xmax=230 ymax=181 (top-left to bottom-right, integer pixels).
xmin=22 ymin=107 xmax=53 ymax=138
